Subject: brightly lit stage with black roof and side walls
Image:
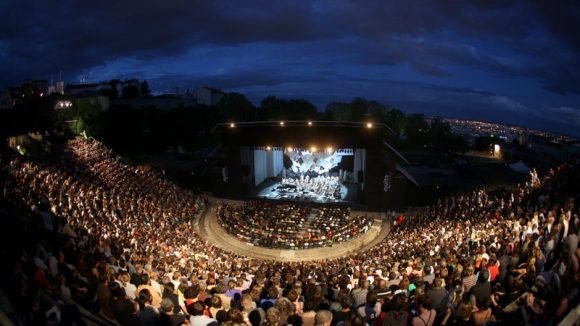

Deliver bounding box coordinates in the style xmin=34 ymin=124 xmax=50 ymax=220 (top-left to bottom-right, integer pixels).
xmin=212 ymin=121 xmax=394 ymax=209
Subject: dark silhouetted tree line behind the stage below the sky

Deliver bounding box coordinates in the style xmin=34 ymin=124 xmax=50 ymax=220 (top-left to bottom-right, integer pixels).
xmin=0 ymin=82 xmax=468 ymax=156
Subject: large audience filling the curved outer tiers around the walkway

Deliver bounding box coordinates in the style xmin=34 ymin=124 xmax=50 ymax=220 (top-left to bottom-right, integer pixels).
xmin=0 ymin=139 xmax=580 ymax=326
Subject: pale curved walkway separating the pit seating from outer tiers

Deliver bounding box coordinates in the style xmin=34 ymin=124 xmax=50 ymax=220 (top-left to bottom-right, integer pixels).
xmin=195 ymin=198 xmax=390 ymax=261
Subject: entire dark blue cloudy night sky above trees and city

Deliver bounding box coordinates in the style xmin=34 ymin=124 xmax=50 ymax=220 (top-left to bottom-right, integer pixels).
xmin=0 ymin=0 xmax=580 ymax=136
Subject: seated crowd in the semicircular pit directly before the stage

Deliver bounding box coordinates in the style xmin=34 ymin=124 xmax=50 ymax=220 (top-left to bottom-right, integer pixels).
xmin=216 ymin=201 xmax=373 ymax=249
